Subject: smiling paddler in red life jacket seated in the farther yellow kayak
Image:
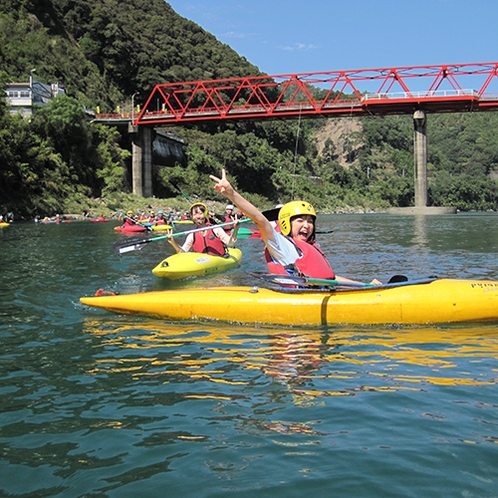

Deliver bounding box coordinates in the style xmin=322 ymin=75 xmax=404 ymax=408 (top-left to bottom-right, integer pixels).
xmin=168 ymin=202 xmax=239 ymax=256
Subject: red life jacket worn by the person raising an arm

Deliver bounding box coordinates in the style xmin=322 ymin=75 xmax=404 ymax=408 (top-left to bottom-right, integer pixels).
xmin=265 ymin=237 xmax=335 ymax=280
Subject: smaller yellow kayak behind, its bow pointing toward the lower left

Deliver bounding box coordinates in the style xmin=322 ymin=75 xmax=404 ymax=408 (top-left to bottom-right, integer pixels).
xmin=152 ymin=247 xmax=242 ymax=280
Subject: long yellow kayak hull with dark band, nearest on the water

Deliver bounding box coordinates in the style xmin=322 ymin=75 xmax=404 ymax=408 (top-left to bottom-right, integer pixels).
xmin=80 ymin=279 xmax=498 ymax=326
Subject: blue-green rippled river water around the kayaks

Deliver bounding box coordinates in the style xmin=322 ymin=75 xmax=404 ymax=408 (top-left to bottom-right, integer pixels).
xmin=0 ymin=213 xmax=498 ymax=498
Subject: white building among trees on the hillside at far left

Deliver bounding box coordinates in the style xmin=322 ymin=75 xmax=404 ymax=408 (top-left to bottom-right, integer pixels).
xmin=5 ymin=78 xmax=65 ymax=117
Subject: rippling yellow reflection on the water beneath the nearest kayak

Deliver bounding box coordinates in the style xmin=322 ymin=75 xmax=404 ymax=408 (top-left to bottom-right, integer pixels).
xmin=84 ymin=317 xmax=498 ymax=404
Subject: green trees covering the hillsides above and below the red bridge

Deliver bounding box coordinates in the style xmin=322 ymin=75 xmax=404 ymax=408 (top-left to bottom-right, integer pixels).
xmin=0 ymin=0 xmax=498 ymax=217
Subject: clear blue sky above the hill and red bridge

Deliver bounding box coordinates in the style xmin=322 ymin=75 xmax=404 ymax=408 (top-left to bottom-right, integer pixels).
xmin=167 ymin=0 xmax=498 ymax=90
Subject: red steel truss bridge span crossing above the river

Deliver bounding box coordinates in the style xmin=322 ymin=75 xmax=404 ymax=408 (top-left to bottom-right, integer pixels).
xmin=125 ymin=62 xmax=498 ymax=125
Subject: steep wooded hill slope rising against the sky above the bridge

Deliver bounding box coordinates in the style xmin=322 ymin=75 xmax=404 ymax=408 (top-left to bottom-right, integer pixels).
xmin=0 ymin=0 xmax=259 ymax=109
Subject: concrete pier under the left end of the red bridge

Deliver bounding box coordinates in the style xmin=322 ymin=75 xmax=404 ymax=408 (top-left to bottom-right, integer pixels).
xmin=128 ymin=124 xmax=153 ymax=197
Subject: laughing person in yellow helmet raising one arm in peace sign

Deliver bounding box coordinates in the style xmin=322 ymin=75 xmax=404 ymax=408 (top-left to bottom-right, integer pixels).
xmin=210 ymin=169 xmax=381 ymax=285
